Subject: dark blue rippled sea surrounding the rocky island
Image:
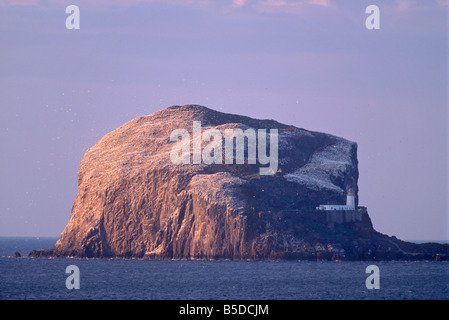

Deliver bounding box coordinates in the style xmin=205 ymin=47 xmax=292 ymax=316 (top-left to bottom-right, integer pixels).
xmin=0 ymin=238 xmax=449 ymax=300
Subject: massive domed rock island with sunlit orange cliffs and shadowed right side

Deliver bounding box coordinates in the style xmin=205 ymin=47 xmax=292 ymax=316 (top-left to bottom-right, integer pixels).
xmin=30 ymin=105 xmax=447 ymax=259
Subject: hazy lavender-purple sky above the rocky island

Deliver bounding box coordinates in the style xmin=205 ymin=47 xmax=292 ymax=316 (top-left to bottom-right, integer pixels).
xmin=0 ymin=0 xmax=449 ymax=240
